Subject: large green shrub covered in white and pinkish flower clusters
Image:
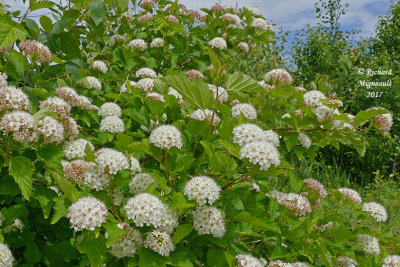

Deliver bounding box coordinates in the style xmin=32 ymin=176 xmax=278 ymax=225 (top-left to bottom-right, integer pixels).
xmin=0 ymin=0 xmax=400 ymax=267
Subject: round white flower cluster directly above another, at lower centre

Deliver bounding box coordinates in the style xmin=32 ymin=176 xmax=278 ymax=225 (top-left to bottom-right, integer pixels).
xmin=183 ymin=176 xmax=221 ymax=205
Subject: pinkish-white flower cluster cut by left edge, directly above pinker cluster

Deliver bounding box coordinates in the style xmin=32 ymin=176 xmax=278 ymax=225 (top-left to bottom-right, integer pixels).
xmin=0 ymin=86 xmax=31 ymax=111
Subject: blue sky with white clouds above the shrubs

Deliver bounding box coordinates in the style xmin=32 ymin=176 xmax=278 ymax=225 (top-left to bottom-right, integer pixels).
xmin=4 ymin=0 xmax=395 ymax=42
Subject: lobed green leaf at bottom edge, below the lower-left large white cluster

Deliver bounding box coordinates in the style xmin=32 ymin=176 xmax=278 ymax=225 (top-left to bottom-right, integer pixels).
xmin=79 ymin=231 xmax=107 ymax=267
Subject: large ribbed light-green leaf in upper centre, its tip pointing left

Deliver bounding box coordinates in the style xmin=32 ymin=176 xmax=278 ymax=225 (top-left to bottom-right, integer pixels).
xmin=162 ymin=75 xmax=213 ymax=109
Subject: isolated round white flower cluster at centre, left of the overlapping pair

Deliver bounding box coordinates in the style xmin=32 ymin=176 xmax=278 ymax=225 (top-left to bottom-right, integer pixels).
xmin=150 ymin=125 xmax=182 ymax=149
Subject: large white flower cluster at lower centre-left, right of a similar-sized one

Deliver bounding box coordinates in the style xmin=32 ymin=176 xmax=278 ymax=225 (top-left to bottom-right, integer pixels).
xmin=124 ymin=193 xmax=176 ymax=228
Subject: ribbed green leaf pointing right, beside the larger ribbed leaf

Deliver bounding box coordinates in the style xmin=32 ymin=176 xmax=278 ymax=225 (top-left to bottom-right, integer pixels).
xmin=226 ymin=72 xmax=265 ymax=93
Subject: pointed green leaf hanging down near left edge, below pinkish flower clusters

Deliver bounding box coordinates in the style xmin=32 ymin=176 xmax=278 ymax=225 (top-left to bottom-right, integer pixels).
xmin=9 ymin=156 xmax=35 ymax=200
